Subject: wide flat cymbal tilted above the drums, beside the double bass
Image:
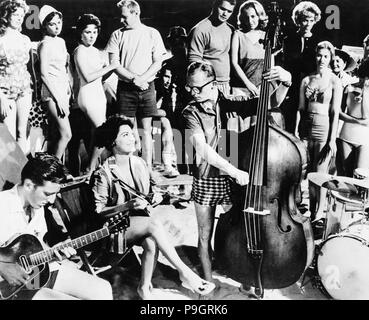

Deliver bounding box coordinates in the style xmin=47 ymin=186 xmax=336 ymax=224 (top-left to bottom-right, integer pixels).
xmin=308 ymin=172 xmax=369 ymax=193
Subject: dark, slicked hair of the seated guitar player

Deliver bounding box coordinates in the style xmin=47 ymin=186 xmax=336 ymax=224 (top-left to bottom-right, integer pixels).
xmin=21 ymin=152 xmax=68 ymax=186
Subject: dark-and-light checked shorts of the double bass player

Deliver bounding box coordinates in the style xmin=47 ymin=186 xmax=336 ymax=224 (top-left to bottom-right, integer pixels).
xmin=192 ymin=177 xmax=232 ymax=206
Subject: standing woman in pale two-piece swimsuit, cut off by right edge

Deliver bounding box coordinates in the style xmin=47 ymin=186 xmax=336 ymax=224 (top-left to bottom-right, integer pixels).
xmin=337 ymin=43 xmax=369 ymax=177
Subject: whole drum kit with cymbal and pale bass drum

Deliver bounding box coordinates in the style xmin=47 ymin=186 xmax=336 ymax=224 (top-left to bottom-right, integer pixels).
xmin=308 ymin=168 xmax=369 ymax=300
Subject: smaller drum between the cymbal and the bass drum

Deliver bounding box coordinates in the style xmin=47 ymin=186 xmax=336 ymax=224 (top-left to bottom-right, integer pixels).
xmin=323 ymin=191 xmax=365 ymax=239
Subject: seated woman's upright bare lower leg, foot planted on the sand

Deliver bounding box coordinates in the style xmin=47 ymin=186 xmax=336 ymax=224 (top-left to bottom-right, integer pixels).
xmin=137 ymin=238 xmax=159 ymax=300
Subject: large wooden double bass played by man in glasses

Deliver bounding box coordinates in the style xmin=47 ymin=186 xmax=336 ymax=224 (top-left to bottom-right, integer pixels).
xmin=214 ymin=3 xmax=314 ymax=297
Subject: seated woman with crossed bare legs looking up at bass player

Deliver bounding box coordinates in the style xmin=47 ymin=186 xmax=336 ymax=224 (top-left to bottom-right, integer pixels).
xmin=91 ymin=117 xmax=215 ymax=300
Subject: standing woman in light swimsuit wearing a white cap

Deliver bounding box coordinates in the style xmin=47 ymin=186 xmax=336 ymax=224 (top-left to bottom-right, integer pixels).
xmin=38 ymin=5 xmax=72 ymax=159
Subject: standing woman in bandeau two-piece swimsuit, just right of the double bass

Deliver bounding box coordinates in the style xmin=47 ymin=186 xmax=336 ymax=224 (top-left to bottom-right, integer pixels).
xmin=295 ymin=41 xmax=342 ymax=220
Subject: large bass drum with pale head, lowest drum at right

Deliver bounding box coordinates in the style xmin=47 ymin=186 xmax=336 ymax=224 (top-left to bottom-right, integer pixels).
xmin=317 ymin=222 xmax=369 ymax=300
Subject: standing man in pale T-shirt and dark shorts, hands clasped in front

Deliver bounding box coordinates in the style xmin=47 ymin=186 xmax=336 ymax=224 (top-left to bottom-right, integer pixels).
xmin=106 ymin=0 xmax=166 ymax=178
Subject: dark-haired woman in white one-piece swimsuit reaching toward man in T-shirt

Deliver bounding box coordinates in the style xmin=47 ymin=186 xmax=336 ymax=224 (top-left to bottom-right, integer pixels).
xmin=73 ymin=14 xmax=118 ymax=173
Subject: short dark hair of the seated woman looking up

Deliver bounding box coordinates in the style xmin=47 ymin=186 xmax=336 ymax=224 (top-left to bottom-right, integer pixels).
xmin=95 ymin=115 xmax=133 ymax=151
